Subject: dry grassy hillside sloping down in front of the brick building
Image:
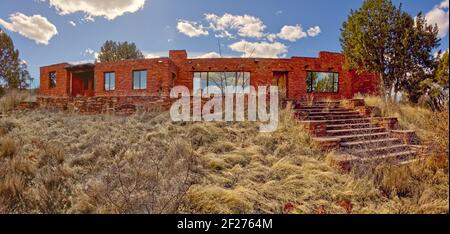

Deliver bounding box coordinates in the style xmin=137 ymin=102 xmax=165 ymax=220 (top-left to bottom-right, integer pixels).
xmin=0 ymin=92 xmax=449 ymax=213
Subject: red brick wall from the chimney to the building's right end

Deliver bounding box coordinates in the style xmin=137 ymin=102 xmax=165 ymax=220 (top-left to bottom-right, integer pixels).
xmin=170 ymin=51 xmax=378 ymax=99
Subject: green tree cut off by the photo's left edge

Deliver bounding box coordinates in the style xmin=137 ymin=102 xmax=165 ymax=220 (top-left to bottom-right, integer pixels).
xmin=0 ymin=30 xmax=31 ymax=90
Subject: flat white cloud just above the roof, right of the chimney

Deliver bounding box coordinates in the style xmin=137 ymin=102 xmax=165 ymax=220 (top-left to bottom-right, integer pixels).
xmin=229 ymin=40 xmax=288 ymax=58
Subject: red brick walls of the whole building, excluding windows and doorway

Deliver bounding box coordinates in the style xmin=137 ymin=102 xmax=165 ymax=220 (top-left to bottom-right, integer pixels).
xmin=40 ymin=50 xmax=379 ymax=112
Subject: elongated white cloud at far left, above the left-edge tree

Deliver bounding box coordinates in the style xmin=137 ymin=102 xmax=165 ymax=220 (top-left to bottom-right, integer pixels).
xmin=0 ymin=12 xmax=58 ymax=45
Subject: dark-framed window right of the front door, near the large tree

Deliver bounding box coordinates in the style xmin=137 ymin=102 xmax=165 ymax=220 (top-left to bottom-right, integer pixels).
xmin=306 ymin=71 xmax=339 ymax=93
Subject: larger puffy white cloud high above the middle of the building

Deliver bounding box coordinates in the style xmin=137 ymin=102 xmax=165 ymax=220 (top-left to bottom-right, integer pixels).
xmin=205 ymin=13 xmax=266 ymax=38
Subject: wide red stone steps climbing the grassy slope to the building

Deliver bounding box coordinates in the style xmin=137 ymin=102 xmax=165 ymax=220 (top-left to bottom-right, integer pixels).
xmin=294 ymin=100 xmax=426 ymax=170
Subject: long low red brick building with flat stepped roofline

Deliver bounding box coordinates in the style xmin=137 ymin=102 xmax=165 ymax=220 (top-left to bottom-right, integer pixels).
xmin=40 ymin=50 xmax=379 ymax=112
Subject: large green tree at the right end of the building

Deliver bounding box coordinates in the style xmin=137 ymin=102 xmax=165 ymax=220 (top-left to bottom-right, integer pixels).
xmin=340 ymin=0 xmax=439 ymax=101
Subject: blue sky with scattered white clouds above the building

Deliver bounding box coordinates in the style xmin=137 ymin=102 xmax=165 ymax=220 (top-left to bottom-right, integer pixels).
xmin=0 ymin=0 xmax=448 ymax=86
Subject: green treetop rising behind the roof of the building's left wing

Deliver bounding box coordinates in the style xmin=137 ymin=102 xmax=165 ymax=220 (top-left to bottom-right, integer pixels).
xmin=97 ymin=41 xmax=144 ymax=63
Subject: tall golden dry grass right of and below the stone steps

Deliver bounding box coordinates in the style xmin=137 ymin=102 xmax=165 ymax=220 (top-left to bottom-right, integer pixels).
xmin=354 ymin=96 xmax=449 ymax=213
